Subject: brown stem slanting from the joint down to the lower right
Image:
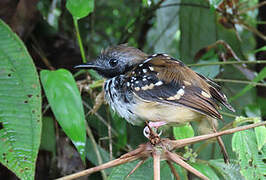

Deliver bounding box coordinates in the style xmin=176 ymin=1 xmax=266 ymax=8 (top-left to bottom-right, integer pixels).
xmin=165 ymin=151 xmax=209 ymax=180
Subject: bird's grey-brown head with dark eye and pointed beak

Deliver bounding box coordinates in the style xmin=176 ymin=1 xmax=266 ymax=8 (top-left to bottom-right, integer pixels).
xmin=75 ymin=44 xmax=148 ymax=78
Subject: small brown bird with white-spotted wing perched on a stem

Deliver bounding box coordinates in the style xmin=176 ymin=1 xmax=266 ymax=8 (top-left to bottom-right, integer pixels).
xmin=75 ymin=44 xmax=235 ymax=162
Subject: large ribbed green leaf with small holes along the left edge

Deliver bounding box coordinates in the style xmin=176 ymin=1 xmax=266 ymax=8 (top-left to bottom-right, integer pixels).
xmin=0 ymin=20 xmax=42 ymax=179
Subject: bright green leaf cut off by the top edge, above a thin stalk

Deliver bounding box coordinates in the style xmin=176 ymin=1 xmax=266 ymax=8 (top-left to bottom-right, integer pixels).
xmin=66 ymin=0 xmax=94 ymax=20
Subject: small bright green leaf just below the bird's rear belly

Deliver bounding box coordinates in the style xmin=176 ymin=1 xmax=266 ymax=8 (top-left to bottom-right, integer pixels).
xmin=173 ymin=123 xmax=194 ymax=140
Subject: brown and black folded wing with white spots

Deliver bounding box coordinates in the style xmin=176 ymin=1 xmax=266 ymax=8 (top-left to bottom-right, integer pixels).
xmin=128 ymin=54 xmax=234 ymax=119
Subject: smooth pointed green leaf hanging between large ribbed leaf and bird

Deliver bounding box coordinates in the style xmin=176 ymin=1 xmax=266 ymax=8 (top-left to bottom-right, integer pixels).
xmin=41 ymin=69 xmax=86 ymax=160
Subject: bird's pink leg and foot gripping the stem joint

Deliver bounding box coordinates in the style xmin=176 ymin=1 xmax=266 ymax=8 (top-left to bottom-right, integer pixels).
xmin=143 ymin=121 xmax=167 ymax=144
